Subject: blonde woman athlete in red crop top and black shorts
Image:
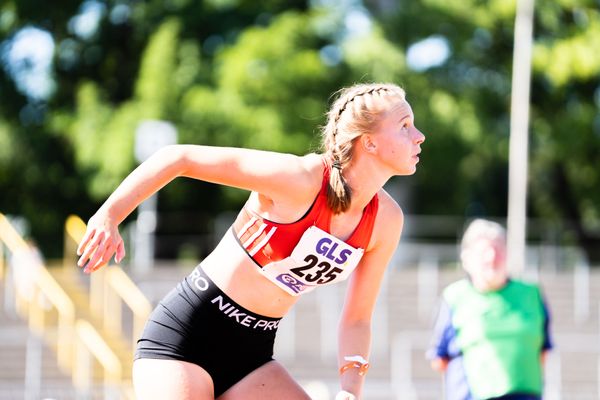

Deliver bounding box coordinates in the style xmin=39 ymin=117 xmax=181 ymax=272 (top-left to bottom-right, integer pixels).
xmin=78 ymin=84 xmax=425 ymax=400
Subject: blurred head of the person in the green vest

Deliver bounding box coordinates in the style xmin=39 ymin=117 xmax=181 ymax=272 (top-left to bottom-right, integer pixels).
xmin=461 ymin=237 xmax=508 ymax=290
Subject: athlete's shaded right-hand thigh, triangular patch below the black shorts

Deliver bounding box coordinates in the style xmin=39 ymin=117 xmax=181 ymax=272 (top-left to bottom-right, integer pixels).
xmin=218 ymin=361 xmax=310 ymax=400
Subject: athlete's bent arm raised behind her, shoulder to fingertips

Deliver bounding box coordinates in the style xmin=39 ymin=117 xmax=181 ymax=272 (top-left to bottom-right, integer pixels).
xmin=77 ymin=145 xmax=322 ymax=272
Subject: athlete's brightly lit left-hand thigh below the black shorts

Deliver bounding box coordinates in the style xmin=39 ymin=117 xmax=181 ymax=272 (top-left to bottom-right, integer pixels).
xmin=133 ymin=358 xmax=214 ymax=400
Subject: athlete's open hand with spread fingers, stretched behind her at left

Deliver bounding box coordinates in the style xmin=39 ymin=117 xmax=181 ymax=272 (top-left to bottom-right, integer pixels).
xmin=77 ymin=211 xmax=125 ymax=274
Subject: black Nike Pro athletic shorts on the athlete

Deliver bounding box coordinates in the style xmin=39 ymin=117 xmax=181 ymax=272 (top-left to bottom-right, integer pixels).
xmin=135 ymin=266 xmax=280 ymax=397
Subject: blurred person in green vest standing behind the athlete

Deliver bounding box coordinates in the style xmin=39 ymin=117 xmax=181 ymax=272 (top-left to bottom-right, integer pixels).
xmin=427 ymin=219 xmax=552 ymax=400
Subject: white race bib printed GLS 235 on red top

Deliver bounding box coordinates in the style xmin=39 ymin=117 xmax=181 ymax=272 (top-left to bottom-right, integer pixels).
xmin=261 ymin=226 xmax=364 ymax=296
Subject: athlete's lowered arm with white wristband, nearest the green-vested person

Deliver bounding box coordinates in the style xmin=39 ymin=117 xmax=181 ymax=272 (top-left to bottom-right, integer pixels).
xmin=338 ymin=190 xmax=404 ymax=398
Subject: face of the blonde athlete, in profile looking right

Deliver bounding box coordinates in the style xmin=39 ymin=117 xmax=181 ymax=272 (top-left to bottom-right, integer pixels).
xmin=372 ymin=101 xmax=425 ymax=175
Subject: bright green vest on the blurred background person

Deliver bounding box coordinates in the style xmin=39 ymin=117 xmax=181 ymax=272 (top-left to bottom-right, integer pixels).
xmin=443 ymin=279 xmax=545 ymax=399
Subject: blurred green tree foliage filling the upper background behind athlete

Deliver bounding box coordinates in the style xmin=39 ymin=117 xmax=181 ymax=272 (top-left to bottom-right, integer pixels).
xmin=0 ymin=0 xmax=600 ymax=256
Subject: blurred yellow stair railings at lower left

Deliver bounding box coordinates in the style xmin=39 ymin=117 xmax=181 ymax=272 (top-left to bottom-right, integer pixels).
xmin=0 ymin=213 xmax=151 ymax=398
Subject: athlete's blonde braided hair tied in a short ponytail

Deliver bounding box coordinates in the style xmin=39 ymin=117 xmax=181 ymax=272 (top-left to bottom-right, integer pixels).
xmin=322 ymin=83 xmax=405 ymax=214
